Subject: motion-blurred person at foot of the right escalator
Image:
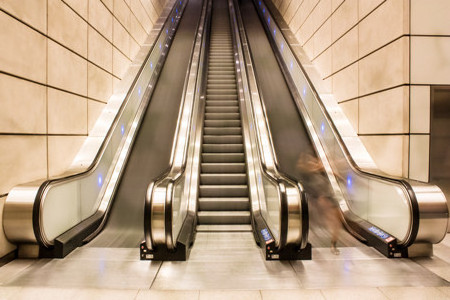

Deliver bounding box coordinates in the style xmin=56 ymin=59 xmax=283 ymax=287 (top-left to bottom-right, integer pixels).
xmin=297 ymin=153 xmax=342 ymax=255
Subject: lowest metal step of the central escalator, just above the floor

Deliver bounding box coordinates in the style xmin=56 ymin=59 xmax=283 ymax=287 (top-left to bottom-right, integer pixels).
xmin=197 ymin=211 xmax=250 ymax=225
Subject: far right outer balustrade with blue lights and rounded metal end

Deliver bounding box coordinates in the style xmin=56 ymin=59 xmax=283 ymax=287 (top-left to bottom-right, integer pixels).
xmin=254 ymin=1 xmax=448 ymax=247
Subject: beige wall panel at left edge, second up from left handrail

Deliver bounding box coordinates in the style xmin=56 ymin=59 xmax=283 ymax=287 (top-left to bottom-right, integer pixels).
xmin=0 ymin=74 xmax=47 ymax=134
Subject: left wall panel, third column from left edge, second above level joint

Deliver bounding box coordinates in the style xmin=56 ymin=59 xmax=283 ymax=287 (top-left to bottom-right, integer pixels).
xmin=88 ymin=63 xmax=112 ymax=103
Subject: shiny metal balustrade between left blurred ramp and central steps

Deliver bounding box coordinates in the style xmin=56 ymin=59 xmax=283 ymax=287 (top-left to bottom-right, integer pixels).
xmin=148 ymin=1 xmax=208 ymax=250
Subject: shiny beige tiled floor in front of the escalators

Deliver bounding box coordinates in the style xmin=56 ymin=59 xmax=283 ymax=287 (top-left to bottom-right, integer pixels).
xmin=0 ymin=232 xmax=450 ymax=299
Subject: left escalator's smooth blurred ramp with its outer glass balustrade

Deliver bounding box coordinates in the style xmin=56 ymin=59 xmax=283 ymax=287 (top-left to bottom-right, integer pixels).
xmin=3 ymin=0 xmax=204 ymax=258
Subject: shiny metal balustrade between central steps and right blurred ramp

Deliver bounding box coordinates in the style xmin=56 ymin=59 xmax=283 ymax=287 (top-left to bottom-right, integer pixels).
xmin=230 ymin=1 xmax=308 ymax=248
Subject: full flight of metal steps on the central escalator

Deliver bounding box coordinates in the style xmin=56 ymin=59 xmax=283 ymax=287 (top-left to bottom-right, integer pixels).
xmin=197 ymin=1 xmax=251 ymax=231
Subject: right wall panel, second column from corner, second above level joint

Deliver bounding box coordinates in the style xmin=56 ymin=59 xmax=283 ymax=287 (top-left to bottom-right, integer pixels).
xmin=333 ymin=64 xmax=358 ymax=102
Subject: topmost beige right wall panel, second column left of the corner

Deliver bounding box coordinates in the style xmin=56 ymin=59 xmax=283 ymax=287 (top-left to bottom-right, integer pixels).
xmin=331 ymin=0 xmax=358 ymax=42
